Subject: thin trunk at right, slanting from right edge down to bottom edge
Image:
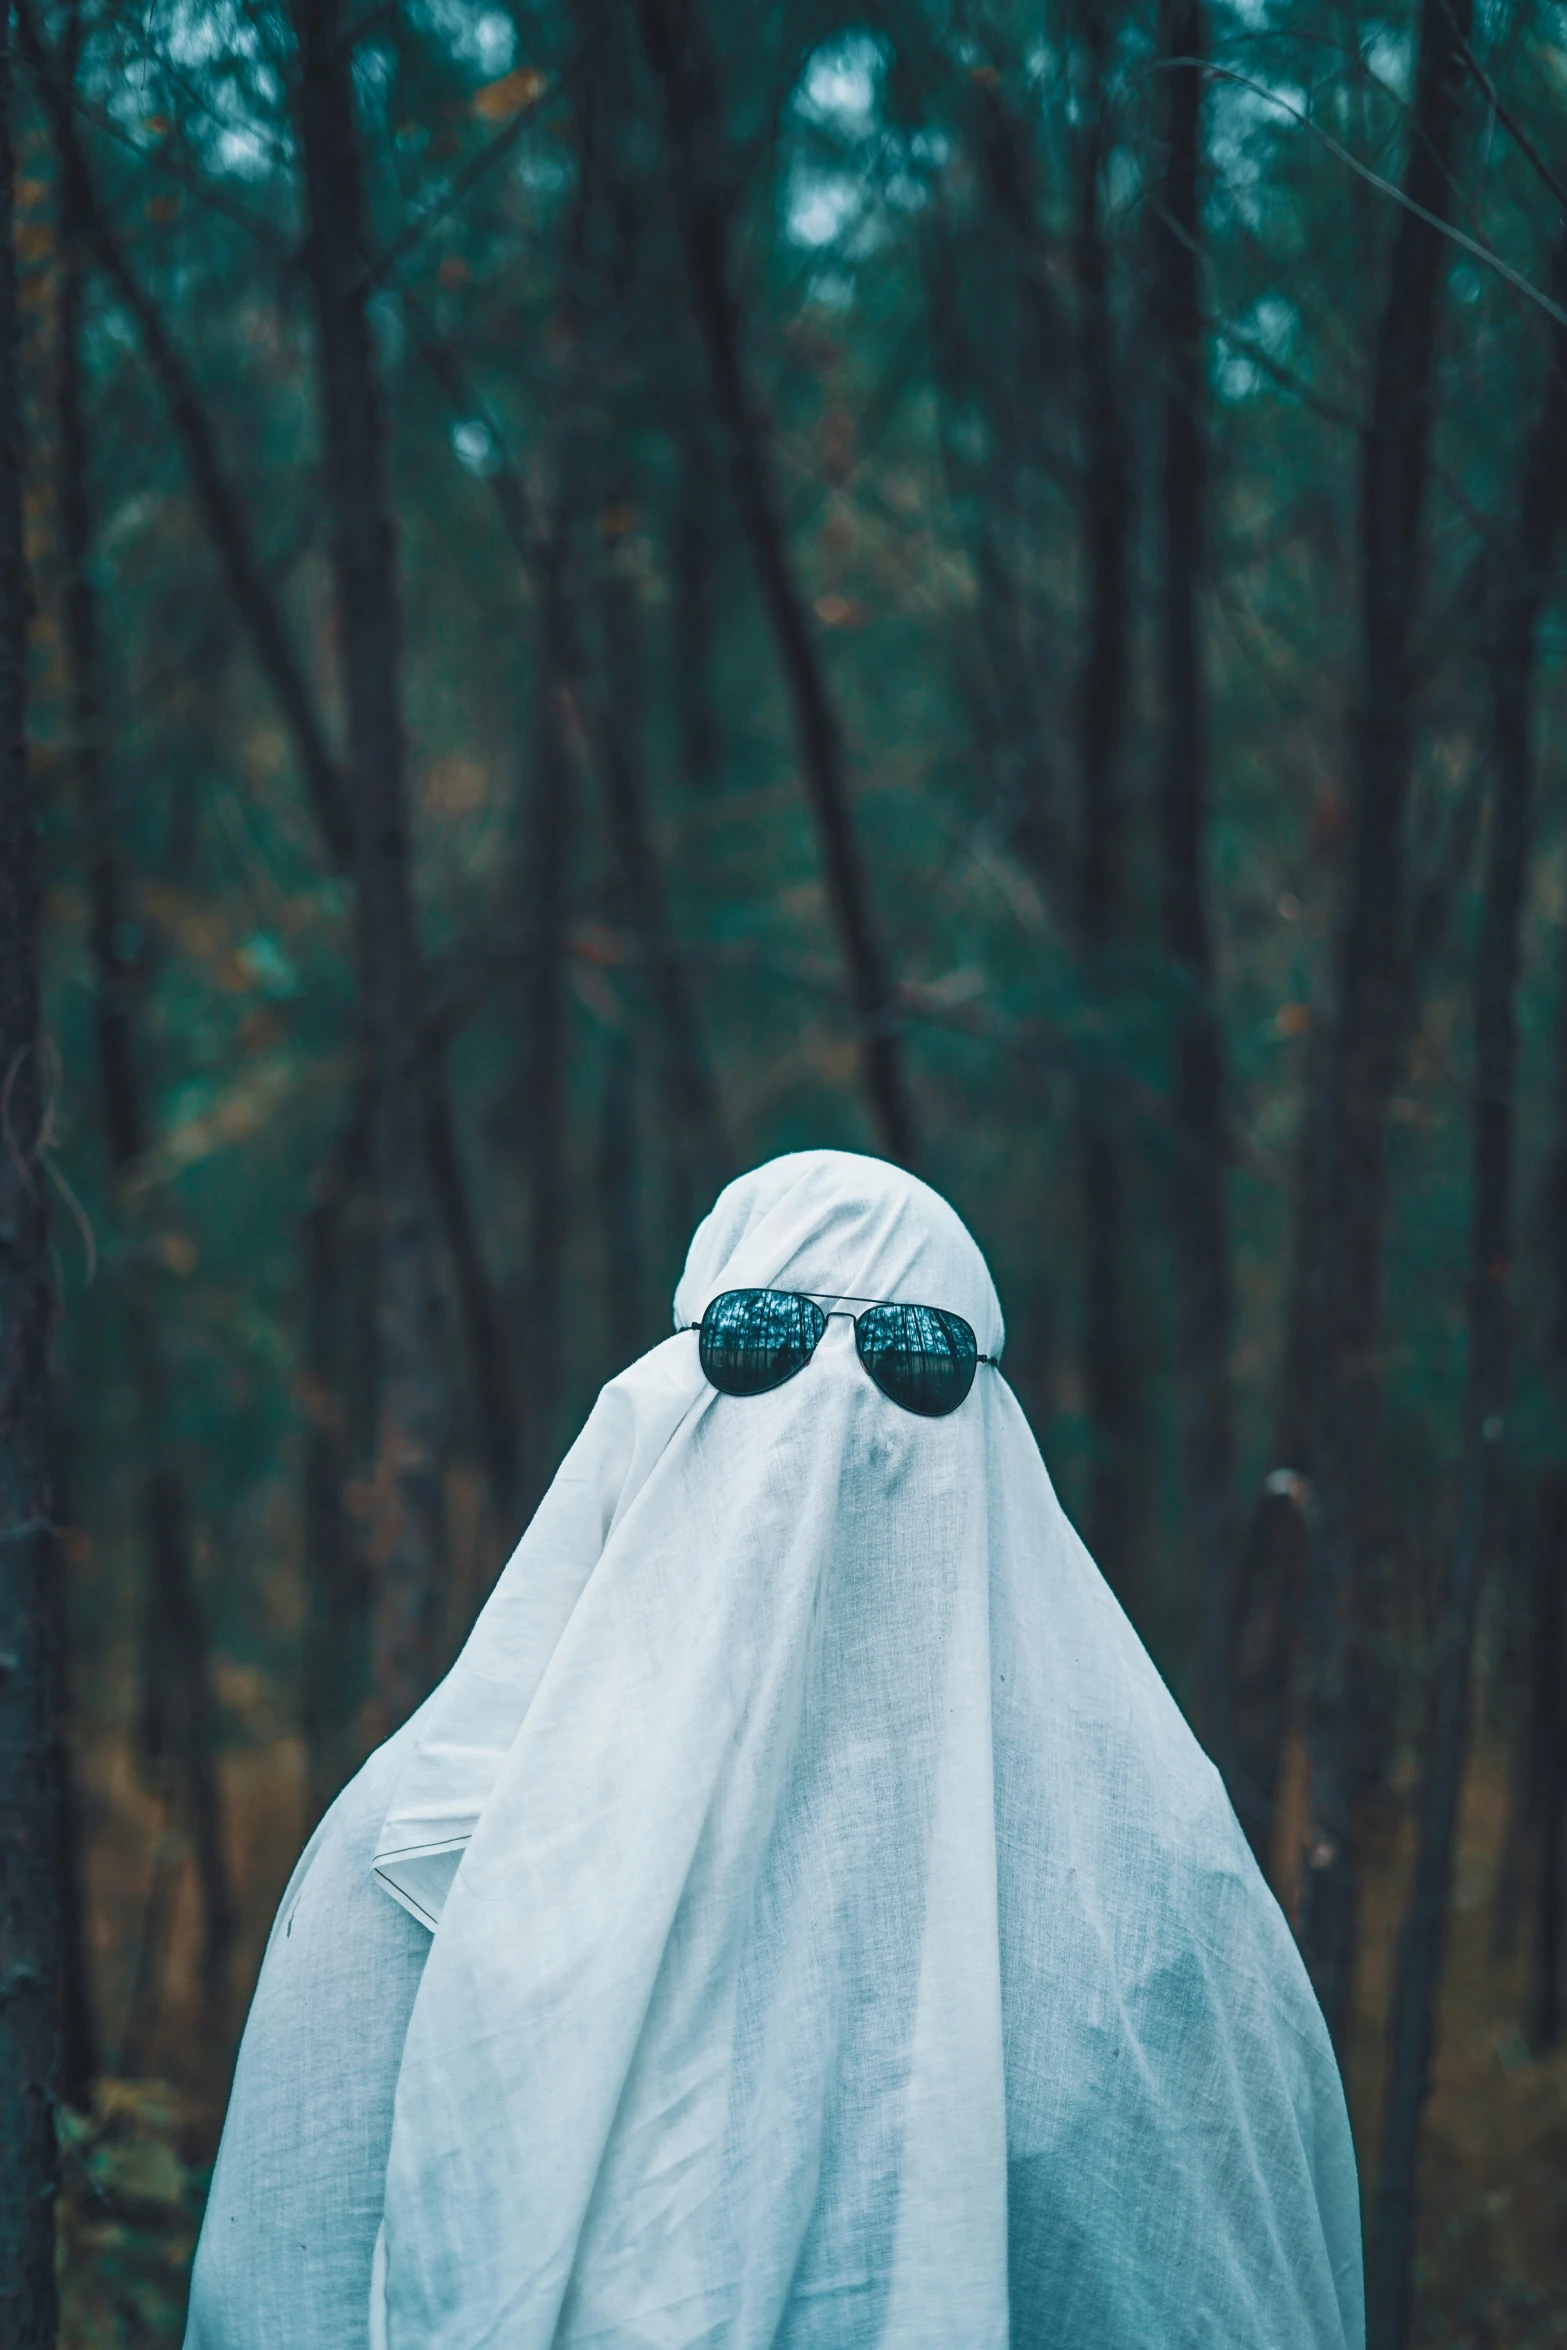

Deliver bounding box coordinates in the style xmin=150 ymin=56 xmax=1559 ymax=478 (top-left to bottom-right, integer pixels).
xmin=1367 ymin=224 xmax=1567 ymax=2350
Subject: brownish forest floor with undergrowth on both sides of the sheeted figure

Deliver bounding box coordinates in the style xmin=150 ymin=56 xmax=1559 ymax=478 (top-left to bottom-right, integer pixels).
xmin=59 ymin=1720 xmax=1567 ymax=2350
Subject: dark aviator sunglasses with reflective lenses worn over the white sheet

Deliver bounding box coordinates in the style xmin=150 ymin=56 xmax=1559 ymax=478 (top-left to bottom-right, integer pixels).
xmin=686 ymin=1290 xmax=996 ymax=1419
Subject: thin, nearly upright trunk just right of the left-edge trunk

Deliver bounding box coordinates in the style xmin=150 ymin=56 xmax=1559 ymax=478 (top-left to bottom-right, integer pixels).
xmin=56 ymin=50 xmax=237 ymax=2047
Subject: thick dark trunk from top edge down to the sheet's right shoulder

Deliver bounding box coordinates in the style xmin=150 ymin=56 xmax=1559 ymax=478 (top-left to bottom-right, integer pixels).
xmin=1302 ymin=0 xmax=1471 ymax=2049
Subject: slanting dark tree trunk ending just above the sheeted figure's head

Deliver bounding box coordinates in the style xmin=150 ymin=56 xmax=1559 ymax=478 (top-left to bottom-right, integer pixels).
xmin=637 ymin=0 xmax=914 ymax=1166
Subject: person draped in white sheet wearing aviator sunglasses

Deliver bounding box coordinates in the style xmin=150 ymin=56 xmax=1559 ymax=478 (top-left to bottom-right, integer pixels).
xmin=188 ymin=1152 xmax=1363 ymax=2350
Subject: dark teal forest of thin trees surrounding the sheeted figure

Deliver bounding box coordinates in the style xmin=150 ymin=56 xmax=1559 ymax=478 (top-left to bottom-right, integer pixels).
xmin=0 ymin=0 xmax=1567 ymax=2350
